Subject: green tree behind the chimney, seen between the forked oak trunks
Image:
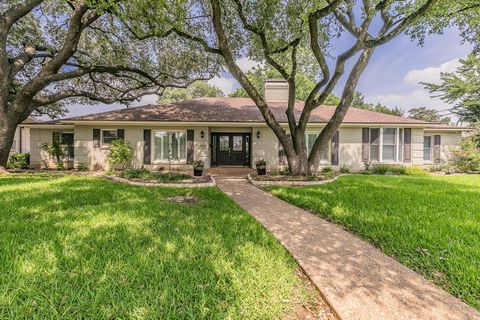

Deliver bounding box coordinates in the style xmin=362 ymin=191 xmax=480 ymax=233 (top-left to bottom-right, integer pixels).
xmin=229 ymin=66 xmax=340 ymax=105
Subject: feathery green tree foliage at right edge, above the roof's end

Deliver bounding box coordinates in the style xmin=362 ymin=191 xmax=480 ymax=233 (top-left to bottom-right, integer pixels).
xmin=423 ymin=53 xmax=480 ymax=124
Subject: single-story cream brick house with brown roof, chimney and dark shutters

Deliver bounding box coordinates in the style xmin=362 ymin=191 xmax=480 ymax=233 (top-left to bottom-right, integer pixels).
xmin=24 ymin=80 xmax=464 ymax=170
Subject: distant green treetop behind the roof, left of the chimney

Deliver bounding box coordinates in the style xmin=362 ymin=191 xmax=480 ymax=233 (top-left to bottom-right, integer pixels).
xmin=158 ymin=81 xmax=225 ymax=104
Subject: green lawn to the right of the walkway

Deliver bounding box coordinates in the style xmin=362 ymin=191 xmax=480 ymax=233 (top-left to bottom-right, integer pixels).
xmin=269 ymin=175 xmax=480 ymax=310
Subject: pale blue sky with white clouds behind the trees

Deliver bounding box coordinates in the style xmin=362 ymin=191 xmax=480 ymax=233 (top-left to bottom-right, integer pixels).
xmin=64 ymin=29 xmax=472 ymax=116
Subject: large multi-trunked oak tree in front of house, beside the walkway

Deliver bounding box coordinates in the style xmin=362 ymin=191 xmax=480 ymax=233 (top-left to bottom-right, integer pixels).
xmin=171 ymin=0 xmax=480 ymax=175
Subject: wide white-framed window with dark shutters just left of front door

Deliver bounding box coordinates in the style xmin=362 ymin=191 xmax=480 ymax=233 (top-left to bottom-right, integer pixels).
xmin=153 ymin=131 xmax=187 ymax=161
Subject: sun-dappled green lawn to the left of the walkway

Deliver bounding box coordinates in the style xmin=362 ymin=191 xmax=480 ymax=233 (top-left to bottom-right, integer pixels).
xmin=0 ymin=174 xmax=313 ymax=319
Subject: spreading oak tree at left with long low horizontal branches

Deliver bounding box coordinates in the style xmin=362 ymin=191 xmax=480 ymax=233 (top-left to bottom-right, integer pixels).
xmin=0 ymin=0 xmax=218 ymax=170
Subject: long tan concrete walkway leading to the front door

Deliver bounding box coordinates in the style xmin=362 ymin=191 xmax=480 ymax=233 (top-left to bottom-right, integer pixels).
xmin=216 ymin=176 xmax=480 ymax=320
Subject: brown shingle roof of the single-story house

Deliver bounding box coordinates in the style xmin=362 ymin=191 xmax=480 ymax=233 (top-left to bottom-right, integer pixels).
xmin=58 ymin=98 xmax=464 ymax=129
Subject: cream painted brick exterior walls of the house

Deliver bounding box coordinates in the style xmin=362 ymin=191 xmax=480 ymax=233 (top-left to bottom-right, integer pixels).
xmin=25 ymin=125 xmax=462 ymax=171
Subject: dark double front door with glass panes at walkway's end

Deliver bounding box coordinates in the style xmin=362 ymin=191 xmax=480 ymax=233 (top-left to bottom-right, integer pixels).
xmin=212 ymin=133 xmax=250 ymax=166
